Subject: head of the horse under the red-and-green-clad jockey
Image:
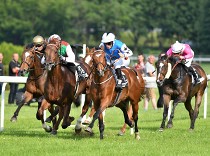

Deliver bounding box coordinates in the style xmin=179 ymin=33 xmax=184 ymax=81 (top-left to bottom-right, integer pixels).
xmin=45 ymin=42 xmax=61 ymax=70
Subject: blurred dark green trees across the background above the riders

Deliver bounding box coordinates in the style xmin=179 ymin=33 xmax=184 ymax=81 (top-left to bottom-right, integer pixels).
xmin=0 ymin=0 xmax=210 ymax=54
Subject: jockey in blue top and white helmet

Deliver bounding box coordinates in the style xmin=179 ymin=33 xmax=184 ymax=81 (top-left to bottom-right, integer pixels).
xmin=99 ymin=33 xmax=133 ymax=90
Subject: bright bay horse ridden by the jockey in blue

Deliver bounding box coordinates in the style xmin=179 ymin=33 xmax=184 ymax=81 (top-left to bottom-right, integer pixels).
xmin=85 ymin=48 xmax=144 ymax=140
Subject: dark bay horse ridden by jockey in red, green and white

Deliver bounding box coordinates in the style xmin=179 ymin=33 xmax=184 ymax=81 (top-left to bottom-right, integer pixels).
xmin=39 ymin=40 xmax=91 ymax=134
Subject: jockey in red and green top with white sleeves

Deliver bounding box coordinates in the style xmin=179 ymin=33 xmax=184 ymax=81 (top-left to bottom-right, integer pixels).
xmin=48 ymin=34 xmax=88 ymax=81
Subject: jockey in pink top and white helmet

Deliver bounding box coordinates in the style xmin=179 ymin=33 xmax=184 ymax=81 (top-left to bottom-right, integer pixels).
xmin=166 ymin=41 xmax=204 ymax=85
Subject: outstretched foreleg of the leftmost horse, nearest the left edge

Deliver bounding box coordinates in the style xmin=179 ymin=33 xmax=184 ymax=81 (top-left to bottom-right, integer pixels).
xmin=10 ymin=91 xmax=33 ymax=122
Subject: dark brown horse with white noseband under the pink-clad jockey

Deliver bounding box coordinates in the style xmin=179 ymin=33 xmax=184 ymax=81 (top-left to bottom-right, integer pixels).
xmin=156 ymin=55 xmax=207 ymax=131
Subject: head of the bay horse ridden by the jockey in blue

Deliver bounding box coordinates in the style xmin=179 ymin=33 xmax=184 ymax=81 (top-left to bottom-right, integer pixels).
xmin=92 ymin=48 xmax=107 ymax=77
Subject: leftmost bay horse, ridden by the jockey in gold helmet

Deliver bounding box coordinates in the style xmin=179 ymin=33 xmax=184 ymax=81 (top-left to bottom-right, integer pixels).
xmin=11 ymin=48 xmax=53 ymax=132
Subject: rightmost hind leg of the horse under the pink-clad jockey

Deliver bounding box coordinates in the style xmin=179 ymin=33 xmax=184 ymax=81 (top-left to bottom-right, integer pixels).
xmin=190 ymin=95 xmax=202 ymax=130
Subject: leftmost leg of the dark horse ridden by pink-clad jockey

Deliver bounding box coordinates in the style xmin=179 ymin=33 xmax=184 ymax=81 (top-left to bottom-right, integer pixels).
xmin=159 ymin=94 xmax=171 ymax=132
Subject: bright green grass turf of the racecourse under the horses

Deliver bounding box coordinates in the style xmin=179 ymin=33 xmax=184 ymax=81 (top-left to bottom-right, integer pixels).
xmin=0 ymin=88 xmax=210 ymax=156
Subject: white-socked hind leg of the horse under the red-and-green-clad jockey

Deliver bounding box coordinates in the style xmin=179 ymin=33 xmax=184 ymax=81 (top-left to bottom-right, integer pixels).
xmin=75 ymin=94 xmax=92 ymax=133
